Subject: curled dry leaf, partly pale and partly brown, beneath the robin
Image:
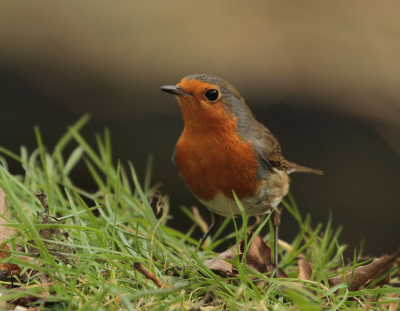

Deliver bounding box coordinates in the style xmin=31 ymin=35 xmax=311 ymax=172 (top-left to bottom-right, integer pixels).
xmin=204 ymin=232 xmax=288 ymax=278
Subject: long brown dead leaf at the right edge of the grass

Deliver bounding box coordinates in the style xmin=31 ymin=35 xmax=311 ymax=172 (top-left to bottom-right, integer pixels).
xmin=328 ymin=249 xmax=400 ymax=291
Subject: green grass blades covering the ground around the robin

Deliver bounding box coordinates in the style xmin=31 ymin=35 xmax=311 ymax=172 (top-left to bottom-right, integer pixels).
xmin=0 ymin=117 xmax=400 ymax=311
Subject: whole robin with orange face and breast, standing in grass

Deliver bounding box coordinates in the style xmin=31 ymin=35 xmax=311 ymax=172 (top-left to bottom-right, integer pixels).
xmin=160 ymin=74 xmax=322 ymax=276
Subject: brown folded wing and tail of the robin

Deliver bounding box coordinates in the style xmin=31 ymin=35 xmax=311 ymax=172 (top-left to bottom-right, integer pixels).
xmin=257 ymin=124 xmax=323 ymax=175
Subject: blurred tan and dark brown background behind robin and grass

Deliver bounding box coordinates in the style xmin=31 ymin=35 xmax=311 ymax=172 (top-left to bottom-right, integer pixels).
xmin=0 ymin=0 xmax=400 ymax=256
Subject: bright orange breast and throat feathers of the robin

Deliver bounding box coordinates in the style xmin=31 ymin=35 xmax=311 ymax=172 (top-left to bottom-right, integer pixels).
xmin=175 ymin=104 xmax=259 ymax=201
